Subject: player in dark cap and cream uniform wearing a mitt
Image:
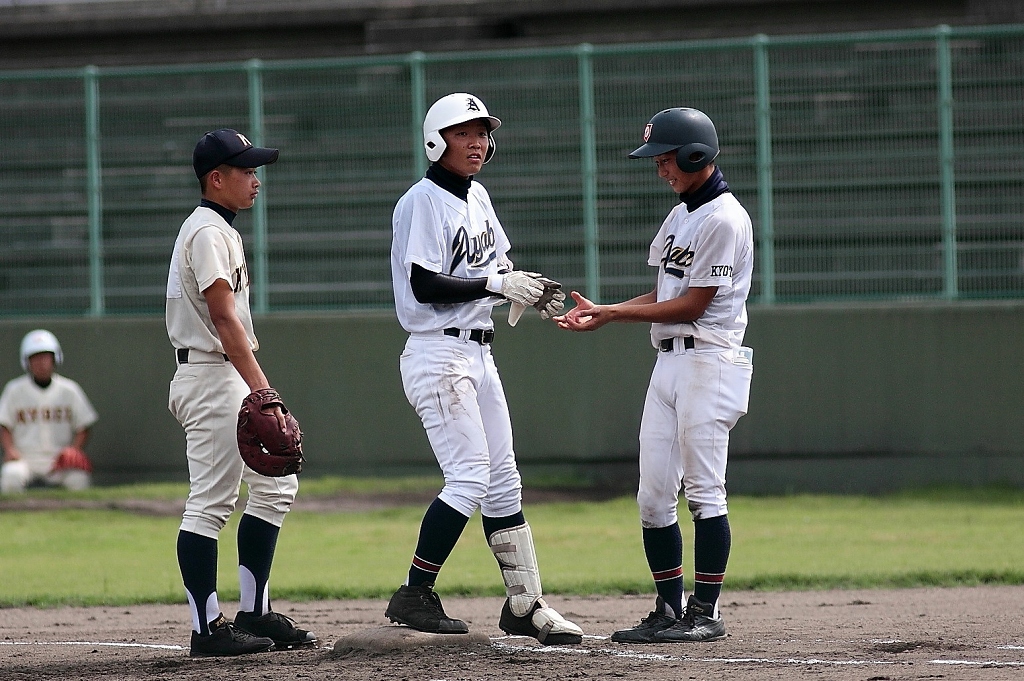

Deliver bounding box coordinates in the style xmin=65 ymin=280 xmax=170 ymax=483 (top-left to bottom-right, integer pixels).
xmin=166 ymin=129 xmax=316 ymax=656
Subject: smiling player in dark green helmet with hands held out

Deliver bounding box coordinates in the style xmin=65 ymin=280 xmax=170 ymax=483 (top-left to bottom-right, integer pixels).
xmin=555 ymin=109 xmax=754 ymax=643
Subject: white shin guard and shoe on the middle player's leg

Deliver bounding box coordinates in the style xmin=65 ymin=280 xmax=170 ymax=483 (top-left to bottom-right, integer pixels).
xmin=487 ymin=523 xmax=583 ymax=645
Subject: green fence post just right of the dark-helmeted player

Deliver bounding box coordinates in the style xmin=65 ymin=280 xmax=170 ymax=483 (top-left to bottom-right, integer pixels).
xmin=754 ymin=34 xmax=775 ymax=304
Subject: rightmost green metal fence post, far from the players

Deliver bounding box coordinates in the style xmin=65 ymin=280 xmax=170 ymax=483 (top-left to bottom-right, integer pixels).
xmin=935 ymin=25 xmax=959 ymax=300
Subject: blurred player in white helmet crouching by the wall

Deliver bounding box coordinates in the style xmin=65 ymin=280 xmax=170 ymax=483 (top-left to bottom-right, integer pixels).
xmin=0 ymin=329 xmax=96 ymax=495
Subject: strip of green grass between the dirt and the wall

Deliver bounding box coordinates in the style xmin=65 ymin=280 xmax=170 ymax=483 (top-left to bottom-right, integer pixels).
xmin=0 ymin=479 xmax=1024 ymax=606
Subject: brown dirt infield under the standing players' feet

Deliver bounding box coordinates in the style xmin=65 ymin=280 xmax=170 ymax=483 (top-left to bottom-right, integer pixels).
xmin=0 ymin=587 xmax=1024 ymax=681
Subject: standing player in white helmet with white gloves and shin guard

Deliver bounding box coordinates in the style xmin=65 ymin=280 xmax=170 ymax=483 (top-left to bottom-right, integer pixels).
xmin=385 ymin=92 xmax=583 ymax=644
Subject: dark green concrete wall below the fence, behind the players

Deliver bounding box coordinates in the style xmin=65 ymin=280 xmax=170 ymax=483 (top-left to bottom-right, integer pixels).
xmin=0 ymin=301 xmax=1024 ymax=493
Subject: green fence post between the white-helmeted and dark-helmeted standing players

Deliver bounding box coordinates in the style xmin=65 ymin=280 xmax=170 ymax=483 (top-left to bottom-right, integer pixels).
xmin=577 ymin=43 xmax=601 ymax=303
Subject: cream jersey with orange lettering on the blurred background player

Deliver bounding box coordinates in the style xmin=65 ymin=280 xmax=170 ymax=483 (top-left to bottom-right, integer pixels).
xmin=0 ymin=374 xmax=97 ymax=462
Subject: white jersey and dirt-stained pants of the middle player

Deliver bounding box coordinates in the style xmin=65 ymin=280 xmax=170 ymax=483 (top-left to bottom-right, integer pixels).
xmin=391 ymin=173 xmax=522 ymax=517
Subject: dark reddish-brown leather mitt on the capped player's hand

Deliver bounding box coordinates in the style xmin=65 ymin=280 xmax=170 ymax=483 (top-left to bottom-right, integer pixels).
xmin=239 ymin=388 xmax=304 ymax=477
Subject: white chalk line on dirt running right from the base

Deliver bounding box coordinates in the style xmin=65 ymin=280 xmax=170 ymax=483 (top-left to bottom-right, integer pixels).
xmin=490 ymin=636 xmax=1024 ymax=667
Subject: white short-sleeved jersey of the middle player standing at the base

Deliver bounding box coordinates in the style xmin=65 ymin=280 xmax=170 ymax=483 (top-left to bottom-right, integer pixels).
xmin=391 ymin=178 xmax=512 ymax=333
